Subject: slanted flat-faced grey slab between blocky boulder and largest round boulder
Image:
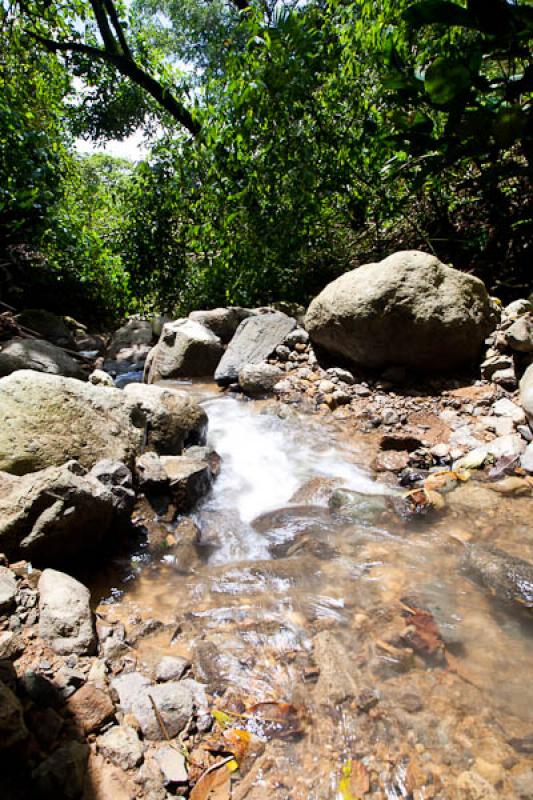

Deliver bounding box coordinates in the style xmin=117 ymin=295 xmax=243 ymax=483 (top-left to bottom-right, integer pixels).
xmin=215 ymin=312 xmax=296 ymax=386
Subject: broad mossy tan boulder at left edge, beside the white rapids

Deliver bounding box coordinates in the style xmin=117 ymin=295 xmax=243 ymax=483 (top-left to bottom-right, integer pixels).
xmin=0 ymin=370 xmax=146 ymax=475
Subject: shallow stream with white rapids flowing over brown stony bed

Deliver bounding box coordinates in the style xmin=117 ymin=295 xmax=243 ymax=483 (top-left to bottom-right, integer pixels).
xmin=91 ymin=387 xmax=533 ymax=800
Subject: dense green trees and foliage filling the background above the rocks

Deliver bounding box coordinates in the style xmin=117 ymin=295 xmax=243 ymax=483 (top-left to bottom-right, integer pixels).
xmin=0 ymin=0 xmax=533 ymax=318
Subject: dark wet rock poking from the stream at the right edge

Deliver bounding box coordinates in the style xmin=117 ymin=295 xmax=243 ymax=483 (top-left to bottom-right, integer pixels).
xmin=461 ymin=545 xmax=533 ymax=609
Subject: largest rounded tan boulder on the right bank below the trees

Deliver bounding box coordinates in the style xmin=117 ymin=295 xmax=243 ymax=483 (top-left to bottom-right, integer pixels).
xmin=305 ymin=250 xmax=494 ymax=372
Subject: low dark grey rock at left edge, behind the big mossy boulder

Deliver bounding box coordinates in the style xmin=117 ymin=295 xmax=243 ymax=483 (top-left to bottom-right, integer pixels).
xmin=0 ymin=337 xmax=85 ymax=378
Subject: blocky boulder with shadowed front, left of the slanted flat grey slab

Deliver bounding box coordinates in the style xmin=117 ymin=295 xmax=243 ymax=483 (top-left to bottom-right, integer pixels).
xmin=147 ymin=319 xmax=224 ymax=383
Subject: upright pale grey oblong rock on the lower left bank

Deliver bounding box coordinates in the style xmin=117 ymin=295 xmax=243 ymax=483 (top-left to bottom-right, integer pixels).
xmin=39 ymin=569 xmax=96 ymax=655
